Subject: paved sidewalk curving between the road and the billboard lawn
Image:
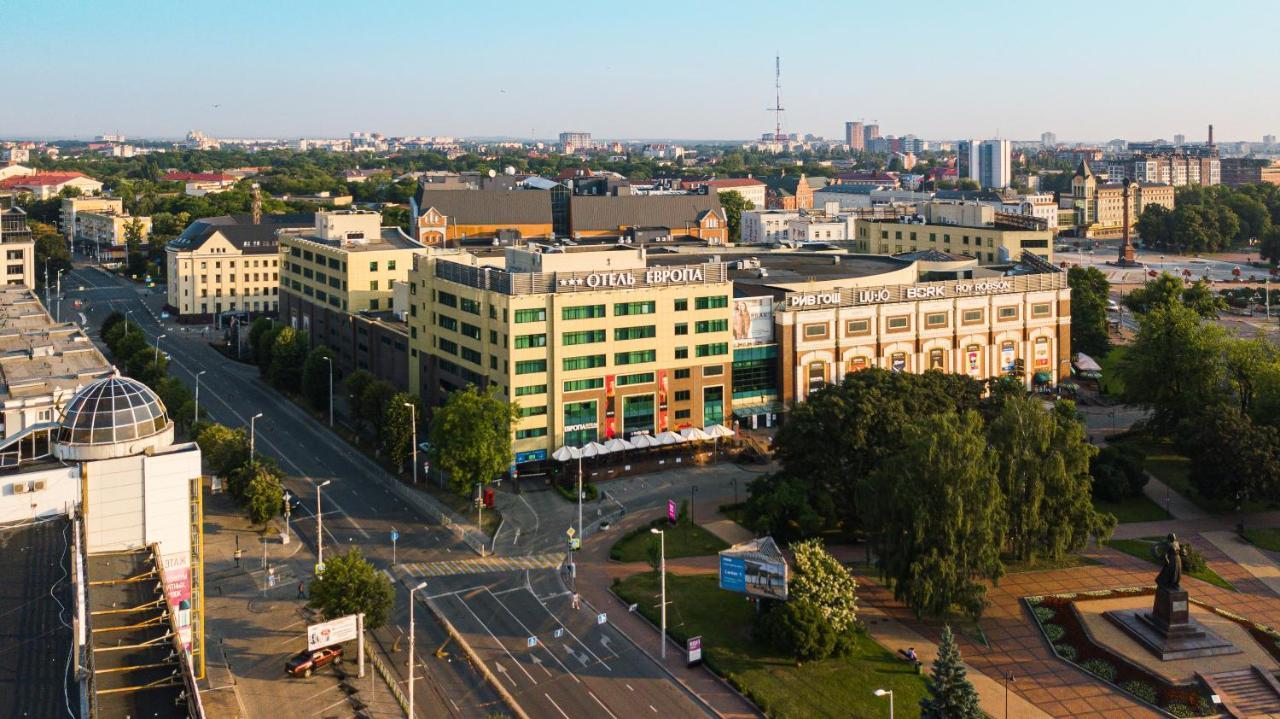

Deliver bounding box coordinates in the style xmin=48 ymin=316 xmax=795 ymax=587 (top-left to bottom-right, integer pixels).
xmin=576 ymin=510 xmax=760 ymax=718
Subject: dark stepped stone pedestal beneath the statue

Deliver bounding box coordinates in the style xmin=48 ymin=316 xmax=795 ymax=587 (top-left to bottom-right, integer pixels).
xmin=1103 ymin=587 xmax=1242 ymax=661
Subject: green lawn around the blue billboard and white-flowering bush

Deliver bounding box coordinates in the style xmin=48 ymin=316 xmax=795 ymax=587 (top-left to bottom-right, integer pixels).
xmin=614 ymin=572 xmax=924 ymax=719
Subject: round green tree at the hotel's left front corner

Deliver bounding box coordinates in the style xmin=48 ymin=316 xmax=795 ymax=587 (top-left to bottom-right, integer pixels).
xmin=429 ymin=385 xmax=517 ymax=495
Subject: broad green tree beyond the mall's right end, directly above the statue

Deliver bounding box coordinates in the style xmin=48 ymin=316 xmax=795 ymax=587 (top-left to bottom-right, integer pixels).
xmin=1119 ymin=303 xmax=1226 ymax=432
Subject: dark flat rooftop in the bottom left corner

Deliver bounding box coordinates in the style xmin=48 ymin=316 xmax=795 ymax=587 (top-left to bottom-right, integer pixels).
xmin=0 ymin=516 xmax=79 ymax=716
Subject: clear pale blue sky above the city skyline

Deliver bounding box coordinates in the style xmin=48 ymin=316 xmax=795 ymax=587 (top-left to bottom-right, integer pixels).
xmin=0 ymin=0 xmax=1280 ymax=141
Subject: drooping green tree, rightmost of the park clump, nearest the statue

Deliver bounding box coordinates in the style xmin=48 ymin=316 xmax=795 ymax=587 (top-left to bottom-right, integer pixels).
xmin=987 ymin=395 xmax=1115 ymax=560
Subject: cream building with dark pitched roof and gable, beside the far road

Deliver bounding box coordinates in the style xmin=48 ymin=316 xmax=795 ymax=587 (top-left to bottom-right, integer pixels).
xmin=165 ymin=208 xmax=314 ymax=317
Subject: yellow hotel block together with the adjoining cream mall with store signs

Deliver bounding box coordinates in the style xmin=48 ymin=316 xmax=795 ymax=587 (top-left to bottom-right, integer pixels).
xmin=408 ymin=244 xmax=1070 ymax=463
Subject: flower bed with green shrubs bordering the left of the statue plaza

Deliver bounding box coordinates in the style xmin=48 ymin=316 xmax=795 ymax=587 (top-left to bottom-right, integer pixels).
xmin=1023 ymin=587 xmax=1213 ymax=716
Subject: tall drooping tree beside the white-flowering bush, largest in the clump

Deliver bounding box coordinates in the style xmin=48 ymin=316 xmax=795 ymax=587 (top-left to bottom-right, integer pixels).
xmin=870 ymin=411 xmax=1006 ymax=618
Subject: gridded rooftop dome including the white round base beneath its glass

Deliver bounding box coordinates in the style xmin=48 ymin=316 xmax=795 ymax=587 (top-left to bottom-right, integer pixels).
xmin=54 ymin=376 xmax=173 ymax=459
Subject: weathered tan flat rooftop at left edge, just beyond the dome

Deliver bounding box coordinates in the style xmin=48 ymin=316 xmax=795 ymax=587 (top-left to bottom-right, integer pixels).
xmin=0 ymin=285 xmax=113 ymax=403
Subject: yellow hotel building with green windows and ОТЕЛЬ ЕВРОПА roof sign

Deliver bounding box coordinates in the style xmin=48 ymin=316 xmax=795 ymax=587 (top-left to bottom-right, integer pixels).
xmin=408 ymin=244 xmax=733 ymax=463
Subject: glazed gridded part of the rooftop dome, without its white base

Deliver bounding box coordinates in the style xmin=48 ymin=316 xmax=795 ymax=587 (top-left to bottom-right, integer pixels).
xmin=58 ymin=377 xmax=169 ymax=445
